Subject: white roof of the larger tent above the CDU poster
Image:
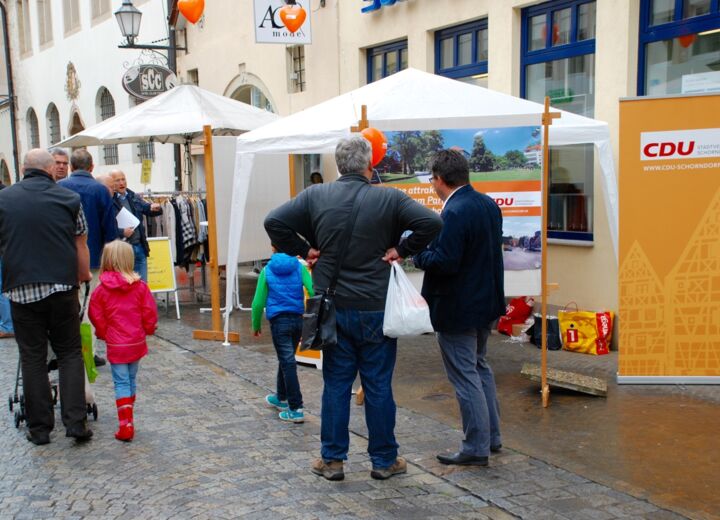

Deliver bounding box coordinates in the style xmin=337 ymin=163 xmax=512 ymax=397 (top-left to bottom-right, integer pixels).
xmin=238 ymin=69 xmax=609 ymax=153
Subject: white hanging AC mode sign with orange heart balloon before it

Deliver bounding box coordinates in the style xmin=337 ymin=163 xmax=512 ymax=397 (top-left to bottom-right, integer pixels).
xmin=254 ymin=0 xmax=312 ymax=45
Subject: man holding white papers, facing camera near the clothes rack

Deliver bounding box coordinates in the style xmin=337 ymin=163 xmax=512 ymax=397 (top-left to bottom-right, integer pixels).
xmin=110 ymin=170 xmax=162 ymax=282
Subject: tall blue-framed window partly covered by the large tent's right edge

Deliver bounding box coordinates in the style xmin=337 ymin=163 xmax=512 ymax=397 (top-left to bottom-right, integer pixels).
xmin=520 ymin=0 xmax=596 ymax=243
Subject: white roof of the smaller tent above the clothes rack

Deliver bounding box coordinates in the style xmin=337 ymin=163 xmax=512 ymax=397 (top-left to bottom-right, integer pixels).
xmin=59 ymin=85 xmax=279 ymax=147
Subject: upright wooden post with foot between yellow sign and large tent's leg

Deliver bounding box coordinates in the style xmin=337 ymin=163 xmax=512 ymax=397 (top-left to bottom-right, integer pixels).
xmin=193 ymin=125 xmax=240 ymax=343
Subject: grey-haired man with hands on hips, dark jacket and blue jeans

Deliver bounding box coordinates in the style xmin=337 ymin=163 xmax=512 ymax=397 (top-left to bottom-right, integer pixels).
xmin=265 ymin=136 xmax=442 ymax=480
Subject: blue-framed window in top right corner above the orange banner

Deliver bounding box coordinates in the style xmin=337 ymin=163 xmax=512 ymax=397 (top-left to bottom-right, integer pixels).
xmin=638 ymin=0 xmax=720 ymax=96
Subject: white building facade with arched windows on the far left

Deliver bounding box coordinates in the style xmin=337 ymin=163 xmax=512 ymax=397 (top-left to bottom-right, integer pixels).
xmin=0 ymin=0 xmax=175 ymax=191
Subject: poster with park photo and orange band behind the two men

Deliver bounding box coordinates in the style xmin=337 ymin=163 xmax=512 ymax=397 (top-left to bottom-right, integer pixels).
xmin=375 ymin=127 xmax=542 ymax=271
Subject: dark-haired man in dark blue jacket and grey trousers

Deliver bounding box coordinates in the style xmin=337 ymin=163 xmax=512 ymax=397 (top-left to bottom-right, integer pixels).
xmin=414 ymin=150 xmax=505 ymax=466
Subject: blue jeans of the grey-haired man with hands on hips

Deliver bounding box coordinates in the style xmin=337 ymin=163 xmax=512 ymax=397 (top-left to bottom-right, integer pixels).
xmin=320 ymin=309 xmax=398 ymax=469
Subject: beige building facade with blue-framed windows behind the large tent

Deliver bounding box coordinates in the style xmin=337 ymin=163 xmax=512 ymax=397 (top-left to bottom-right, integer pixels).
xmin=173 ymin=0 xmax=720 ymax=316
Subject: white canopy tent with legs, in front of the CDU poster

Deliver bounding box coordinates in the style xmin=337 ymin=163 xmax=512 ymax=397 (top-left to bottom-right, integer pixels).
xmin=225 ymin=69 xmax=618 ymax=340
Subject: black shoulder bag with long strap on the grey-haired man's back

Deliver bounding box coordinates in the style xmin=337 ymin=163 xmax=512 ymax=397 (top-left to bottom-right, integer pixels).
xmin=300 ymin=183 xmax=370 ymax=351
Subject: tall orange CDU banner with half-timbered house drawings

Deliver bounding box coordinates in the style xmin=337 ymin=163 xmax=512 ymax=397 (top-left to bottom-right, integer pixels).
xmin=618 ymin=95 xmax=720 ymax=382
